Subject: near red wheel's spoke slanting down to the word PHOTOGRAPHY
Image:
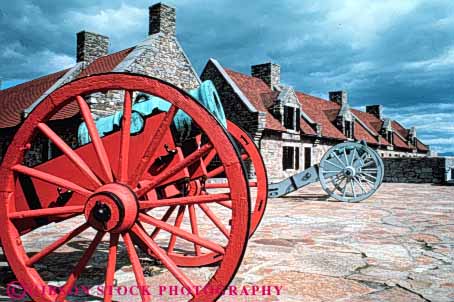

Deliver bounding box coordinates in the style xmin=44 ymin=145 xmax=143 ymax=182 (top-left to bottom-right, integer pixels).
xmin=132 ymin=225 xmax=196 ymax=296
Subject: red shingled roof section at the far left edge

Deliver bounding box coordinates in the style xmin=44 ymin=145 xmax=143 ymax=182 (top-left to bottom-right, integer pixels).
xmin=0 ymin=69 xmax=68 ymax=128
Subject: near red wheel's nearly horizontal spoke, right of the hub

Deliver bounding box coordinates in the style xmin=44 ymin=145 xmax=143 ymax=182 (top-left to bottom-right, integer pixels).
xmin=139 ymin=193 xmax=231 ymax=210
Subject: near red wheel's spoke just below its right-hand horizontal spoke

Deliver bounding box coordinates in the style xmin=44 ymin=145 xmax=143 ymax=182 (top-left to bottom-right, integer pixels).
xmin=139 ymin=213 xmax=225 ymax=255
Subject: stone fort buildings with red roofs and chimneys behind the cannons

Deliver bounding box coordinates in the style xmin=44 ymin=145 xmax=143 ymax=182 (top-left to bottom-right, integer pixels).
xmin=0 ymin=3 xmax=429 ymax=179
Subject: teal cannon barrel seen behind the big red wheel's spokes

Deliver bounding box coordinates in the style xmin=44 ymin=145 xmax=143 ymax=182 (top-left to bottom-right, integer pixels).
xmin=77 ymin=81 xmax=227 ymax=145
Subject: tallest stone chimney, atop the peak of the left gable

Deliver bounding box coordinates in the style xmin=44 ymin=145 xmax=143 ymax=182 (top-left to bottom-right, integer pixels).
xmin=148 ymin=3 xmax=176 ymax=36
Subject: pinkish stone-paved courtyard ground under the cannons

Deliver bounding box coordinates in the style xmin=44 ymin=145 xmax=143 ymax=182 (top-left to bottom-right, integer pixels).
xmin=0 ymin=184 xmax=454 ymax=302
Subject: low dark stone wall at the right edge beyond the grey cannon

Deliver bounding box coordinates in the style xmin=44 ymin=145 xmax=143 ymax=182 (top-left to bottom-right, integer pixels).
xmin=383 ymin=157 xmax=454 ymax=184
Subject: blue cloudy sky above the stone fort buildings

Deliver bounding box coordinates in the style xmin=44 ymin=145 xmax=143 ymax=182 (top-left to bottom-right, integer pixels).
xmin=0 ymin=0 xmax=454 ymax=152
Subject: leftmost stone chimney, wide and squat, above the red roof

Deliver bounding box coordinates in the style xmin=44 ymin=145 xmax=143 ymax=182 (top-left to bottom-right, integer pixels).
xmin=77 ymin=31 xmax=109 ymax=63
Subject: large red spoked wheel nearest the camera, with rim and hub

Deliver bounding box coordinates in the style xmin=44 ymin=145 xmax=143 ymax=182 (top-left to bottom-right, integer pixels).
xmin=0 ymin=73 xmax=250 ymax=301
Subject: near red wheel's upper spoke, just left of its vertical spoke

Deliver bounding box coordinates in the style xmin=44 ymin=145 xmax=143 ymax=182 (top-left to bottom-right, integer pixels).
xmin=76 ymin=95 xmax=113 ymax=183
